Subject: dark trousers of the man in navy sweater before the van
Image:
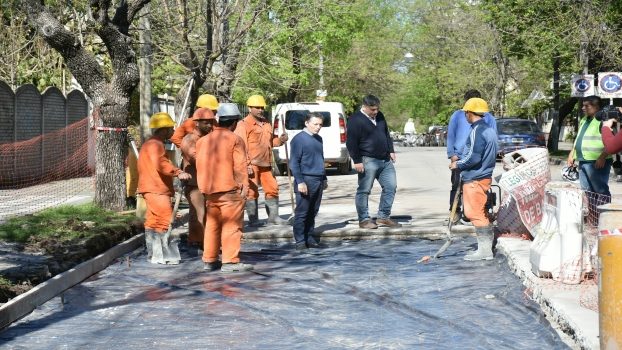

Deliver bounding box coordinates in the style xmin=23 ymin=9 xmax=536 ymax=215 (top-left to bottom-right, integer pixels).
xmin=294 ymin=175 xmax=324 ymax=243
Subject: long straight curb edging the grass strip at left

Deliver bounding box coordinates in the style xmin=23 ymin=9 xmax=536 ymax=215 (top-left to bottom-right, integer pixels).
xmin=0 ymin=234 xmax=145 ymax=329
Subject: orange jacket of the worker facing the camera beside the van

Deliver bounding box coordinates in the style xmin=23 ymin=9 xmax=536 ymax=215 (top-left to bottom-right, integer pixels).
xmin=235 ymin=114 xmax=282 ymax=167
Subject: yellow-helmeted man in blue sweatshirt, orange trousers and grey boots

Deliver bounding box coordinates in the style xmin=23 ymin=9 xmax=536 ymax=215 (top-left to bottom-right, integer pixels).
xmin=449 ymin=98 xmax=497 ymax=261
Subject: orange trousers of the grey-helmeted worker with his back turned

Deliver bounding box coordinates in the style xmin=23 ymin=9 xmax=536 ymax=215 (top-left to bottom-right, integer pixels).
xmin=203 ymin=191 xmax=245 ymax=264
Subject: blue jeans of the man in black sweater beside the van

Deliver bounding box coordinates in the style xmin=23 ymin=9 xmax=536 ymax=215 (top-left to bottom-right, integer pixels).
xmin=354 ymin=157 xmax=397 ymax=222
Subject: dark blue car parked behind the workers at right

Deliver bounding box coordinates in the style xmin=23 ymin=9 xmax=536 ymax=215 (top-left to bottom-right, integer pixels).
xmin=497 ymin=118 xmax=546 ymax=157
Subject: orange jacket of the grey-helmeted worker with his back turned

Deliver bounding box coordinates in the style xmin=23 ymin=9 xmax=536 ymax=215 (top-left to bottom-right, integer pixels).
xmin=196 ymin=126 xmax=248 ymax=195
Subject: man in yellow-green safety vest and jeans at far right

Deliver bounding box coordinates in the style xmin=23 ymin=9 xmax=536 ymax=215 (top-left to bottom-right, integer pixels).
xmin=567 ymin=96 xmax=613 ymax=224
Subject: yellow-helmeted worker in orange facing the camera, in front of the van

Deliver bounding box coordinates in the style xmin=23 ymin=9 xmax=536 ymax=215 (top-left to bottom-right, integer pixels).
xmin=235 ymin=95 xmax=287 ymax=226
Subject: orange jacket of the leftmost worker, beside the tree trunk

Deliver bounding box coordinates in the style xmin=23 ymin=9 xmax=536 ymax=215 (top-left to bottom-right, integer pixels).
xmin=136 ymin=136 xmax=181 ymax=196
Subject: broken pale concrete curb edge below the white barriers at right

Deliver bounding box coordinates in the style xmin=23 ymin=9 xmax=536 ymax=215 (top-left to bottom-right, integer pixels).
xmin=497 ymin=238 xmax=600 ymax=349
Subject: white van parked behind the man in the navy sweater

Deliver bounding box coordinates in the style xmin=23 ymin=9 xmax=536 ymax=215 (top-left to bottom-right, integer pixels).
xmin=272 ymin=102 xmax=352 ymax=175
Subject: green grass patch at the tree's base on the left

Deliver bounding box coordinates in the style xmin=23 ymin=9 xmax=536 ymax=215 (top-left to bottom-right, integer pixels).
xmin=0 ymin=204 xmax=136 ymax=243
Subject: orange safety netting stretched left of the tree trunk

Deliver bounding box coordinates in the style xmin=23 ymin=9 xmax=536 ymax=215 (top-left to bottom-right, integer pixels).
xmin=0 ymin=118 xmax=94 ymax=221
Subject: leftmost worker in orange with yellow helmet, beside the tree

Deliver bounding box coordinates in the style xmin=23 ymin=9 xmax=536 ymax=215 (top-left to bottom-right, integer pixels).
xmin=137 ymin=112 xmax=191 ymax=264
